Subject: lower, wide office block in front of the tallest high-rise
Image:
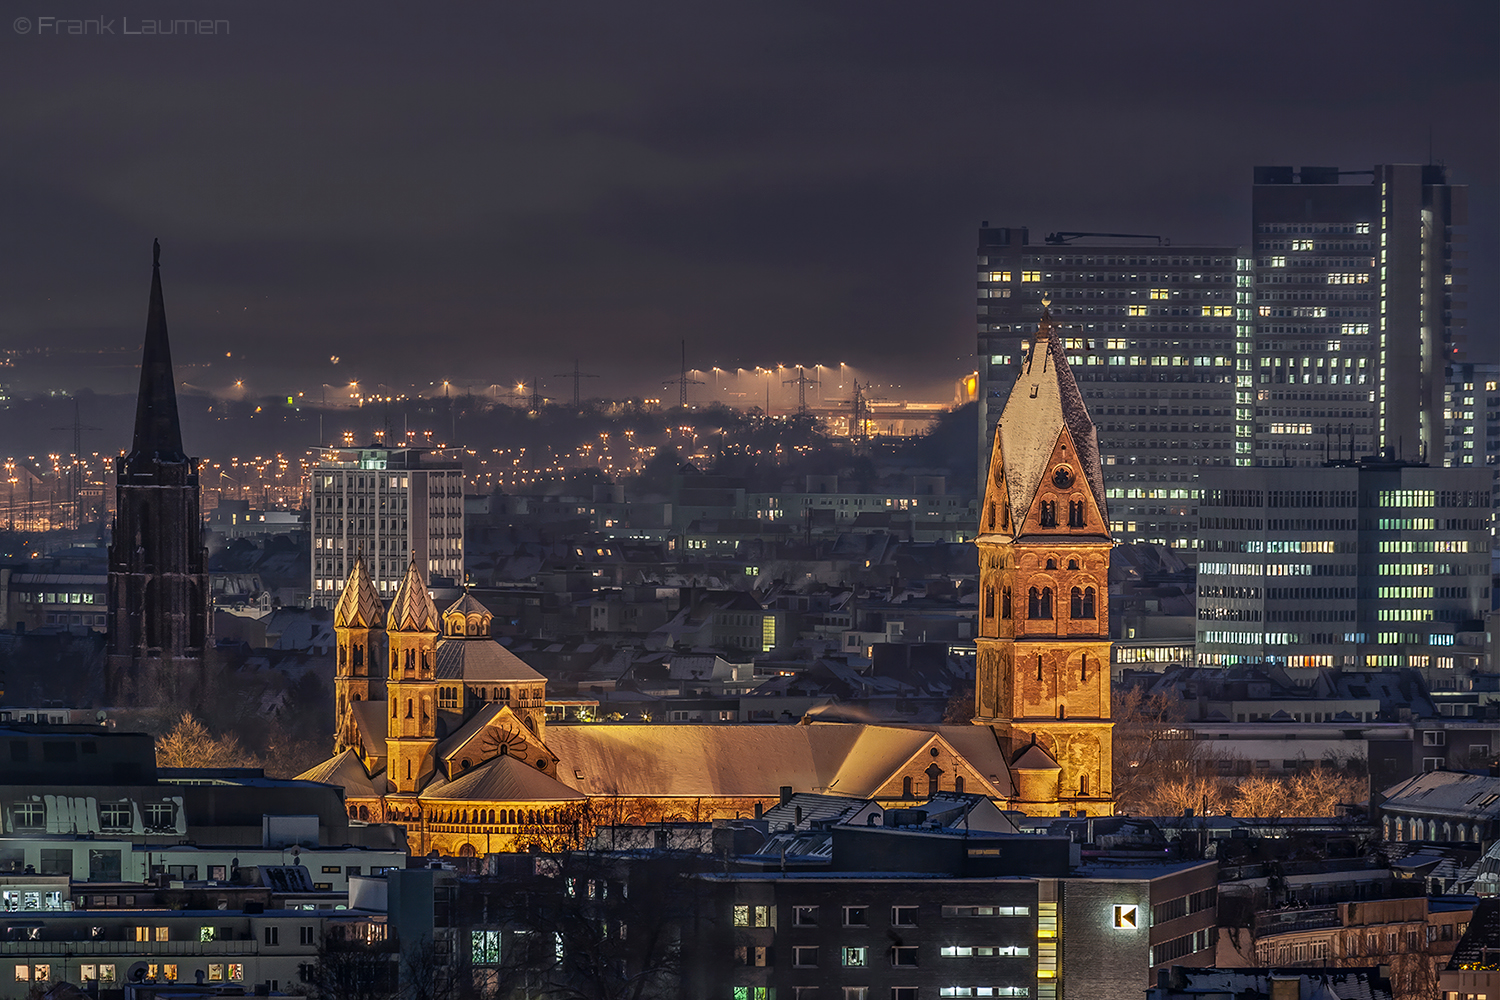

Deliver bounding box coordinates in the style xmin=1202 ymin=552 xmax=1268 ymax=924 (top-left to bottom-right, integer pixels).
xmin=1197 ymin=459 xmax=1491 ymax=672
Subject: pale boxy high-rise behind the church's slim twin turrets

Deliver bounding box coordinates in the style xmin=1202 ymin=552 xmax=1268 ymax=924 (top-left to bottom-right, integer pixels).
xmin=312 ymin=445 xmax=464 ymax=607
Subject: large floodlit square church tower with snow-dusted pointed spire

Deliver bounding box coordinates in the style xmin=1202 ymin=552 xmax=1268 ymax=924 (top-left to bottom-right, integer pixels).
xmin=974 ymin=307 xmax=1115 ymax=816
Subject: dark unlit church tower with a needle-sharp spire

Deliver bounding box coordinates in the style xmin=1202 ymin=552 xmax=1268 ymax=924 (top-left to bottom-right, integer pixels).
xmin=105 ymin=244 xmax=209 ymax=708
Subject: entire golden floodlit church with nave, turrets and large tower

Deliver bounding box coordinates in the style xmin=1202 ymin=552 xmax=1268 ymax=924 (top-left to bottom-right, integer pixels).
xmin=300 ymin=315 xmax=1115 ymax=855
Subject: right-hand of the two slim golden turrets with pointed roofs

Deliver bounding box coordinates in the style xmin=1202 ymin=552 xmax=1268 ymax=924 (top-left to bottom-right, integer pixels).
xmin=386 ymin=556 xmax=440 ymax=795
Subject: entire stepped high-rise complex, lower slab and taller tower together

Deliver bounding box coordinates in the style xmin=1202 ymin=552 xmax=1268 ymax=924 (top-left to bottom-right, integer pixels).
xmin=977 ymin=165 xmax=1467 ymax=547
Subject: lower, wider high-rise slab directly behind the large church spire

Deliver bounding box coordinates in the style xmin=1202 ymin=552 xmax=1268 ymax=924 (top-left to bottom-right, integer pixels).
xmin=978 ymin=223 xmax=1253 ymax=547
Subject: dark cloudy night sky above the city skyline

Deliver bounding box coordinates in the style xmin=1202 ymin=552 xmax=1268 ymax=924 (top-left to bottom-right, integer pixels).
xmin=0 ymin=0 xmax=1500 ymax=396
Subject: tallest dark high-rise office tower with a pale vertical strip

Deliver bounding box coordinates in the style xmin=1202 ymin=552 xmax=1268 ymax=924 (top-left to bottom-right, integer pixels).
xmin=1251 ymin=163 xmax=1467 ymax=466
